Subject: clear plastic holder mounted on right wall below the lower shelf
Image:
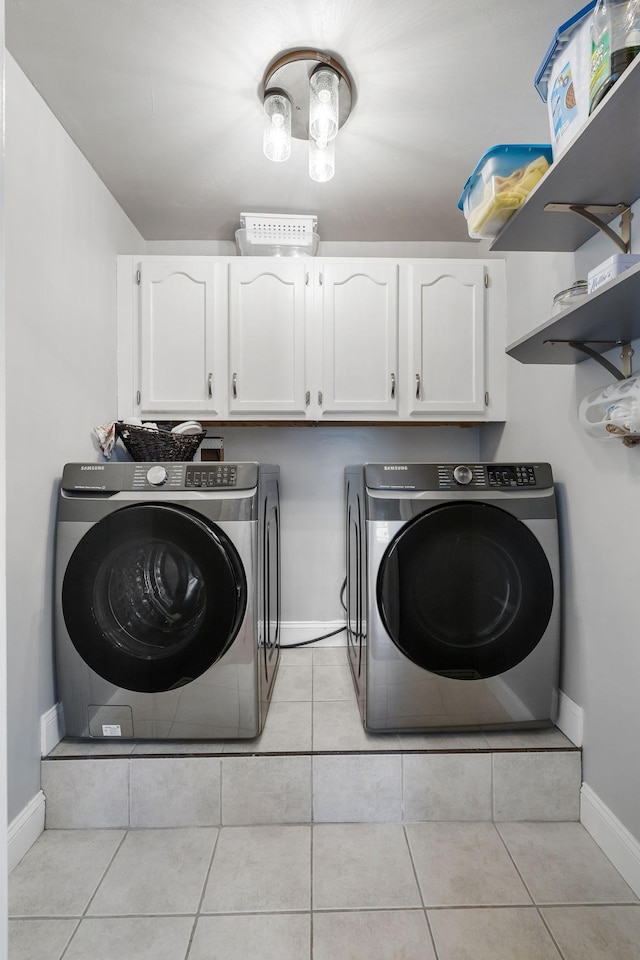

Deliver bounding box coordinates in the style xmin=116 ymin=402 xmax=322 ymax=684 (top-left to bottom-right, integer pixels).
xmin=578 ymin=377 xmax=640 ymax=440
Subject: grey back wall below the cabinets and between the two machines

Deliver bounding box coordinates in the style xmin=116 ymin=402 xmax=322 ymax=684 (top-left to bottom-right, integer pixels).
xmin=220 ymin=425 xmax=483 ymax=624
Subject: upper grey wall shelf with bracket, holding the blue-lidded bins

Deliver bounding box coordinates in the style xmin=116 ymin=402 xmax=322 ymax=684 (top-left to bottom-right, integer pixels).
xmin=491 ymin=57 xmax=640 ymax=251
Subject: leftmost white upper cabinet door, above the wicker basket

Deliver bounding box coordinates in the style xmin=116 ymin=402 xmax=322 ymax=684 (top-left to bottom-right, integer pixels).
xmin=138 ymin=257 xmax=226 ymax=416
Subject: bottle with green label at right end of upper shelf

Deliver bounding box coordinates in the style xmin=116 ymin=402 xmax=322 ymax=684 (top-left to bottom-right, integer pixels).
xmin=589 ymin=0 xmax=640 ymax=113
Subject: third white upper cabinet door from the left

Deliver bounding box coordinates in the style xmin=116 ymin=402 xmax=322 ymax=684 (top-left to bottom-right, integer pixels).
xmin=316 ymin=260 xmax=398 ymax=414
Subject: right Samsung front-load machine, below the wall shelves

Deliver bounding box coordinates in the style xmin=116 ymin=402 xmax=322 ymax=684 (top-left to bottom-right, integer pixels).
xmin=346 ymin=461 xmax=560 ymax=732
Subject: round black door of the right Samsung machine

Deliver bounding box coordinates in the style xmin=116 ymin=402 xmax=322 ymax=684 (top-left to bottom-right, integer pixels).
xmin=377 ymin=501 xmax=554 ymax=680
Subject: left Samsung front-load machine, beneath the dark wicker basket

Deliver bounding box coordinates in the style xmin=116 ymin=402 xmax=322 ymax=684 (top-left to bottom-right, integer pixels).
xmin=54 ymin=462 xmax=280 ymax=740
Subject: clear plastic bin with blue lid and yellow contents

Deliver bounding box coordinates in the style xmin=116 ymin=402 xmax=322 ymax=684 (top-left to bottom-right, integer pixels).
xmin=458 ymin=143 xmax=553 ymax=240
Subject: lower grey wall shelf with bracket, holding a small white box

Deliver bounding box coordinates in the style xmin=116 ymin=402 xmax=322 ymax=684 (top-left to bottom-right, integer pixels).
xmin=507 ymin=264 xmax=640 ymax=364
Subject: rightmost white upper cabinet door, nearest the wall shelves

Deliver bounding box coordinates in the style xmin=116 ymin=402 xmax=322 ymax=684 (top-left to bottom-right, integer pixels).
xmin=403 ymin=260 xmax=485 ymax=416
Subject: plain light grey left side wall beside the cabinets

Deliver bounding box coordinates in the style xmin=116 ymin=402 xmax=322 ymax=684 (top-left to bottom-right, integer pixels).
xmin=5 ymin=54 xmax=143 ymax=819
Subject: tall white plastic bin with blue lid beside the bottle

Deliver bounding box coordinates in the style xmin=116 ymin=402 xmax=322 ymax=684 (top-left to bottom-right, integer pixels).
xmin=534 ymin=0 xmax=596 ymax=159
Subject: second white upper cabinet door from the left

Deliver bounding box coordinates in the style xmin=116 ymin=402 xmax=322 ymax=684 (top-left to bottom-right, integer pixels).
xmin=228 ymin=258 xmax=308 ymax=416
